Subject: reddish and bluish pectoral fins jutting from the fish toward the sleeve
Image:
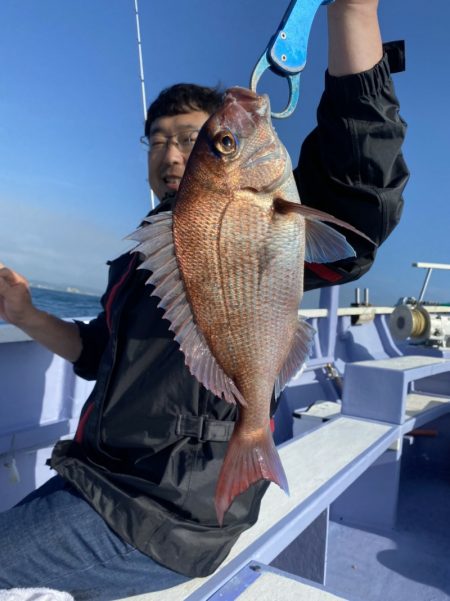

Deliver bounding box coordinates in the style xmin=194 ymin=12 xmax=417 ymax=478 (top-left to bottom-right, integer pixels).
xmin=274 ymin=198 xmax=375 ymax=263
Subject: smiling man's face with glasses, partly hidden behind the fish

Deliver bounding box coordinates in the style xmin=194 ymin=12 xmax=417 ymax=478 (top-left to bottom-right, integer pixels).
xmin=148 ymin=111 xmax=209 ymax=200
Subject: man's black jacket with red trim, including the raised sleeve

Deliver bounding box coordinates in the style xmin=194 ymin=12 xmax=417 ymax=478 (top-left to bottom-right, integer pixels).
xmin=51 ymin=47 xmax=407 ymax=576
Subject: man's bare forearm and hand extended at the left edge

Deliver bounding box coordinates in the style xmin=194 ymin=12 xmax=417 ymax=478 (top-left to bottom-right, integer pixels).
xmin=0 ymin=263 xmax=82 ymax=362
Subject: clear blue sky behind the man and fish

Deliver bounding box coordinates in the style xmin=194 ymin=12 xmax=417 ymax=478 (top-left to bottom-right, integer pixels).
xmin=0 ymin=0 xmax=450 ymax=305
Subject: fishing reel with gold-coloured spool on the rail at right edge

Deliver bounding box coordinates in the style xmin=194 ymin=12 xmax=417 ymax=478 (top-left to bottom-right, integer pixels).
xmin=389 ymin=297 xmax=450 ymax=348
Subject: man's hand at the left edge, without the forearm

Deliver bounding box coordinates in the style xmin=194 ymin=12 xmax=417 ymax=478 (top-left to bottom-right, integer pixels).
xmin=0 ymin=263 xmax=36 ymax=327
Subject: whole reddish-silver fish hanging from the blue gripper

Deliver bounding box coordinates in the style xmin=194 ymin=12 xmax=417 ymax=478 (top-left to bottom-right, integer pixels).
xmin=130 ymin=87 xmax=374 ymax=525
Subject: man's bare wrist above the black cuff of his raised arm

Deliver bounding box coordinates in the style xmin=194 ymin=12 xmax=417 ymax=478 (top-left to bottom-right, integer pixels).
xmin=328 ymin=0 xmax=383 ymax=76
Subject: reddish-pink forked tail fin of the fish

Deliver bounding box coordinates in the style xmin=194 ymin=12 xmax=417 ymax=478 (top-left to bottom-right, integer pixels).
xmin=215 ymin=426 xmax=289 ymax=526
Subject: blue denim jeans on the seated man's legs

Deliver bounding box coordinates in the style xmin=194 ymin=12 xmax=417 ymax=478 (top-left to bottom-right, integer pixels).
xmin=0 ymin=476 xmax=188 ymax=601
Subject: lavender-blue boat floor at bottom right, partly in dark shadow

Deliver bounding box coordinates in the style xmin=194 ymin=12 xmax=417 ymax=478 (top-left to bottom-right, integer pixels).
xmin=326 ymin=418 xmax=450 ymax=601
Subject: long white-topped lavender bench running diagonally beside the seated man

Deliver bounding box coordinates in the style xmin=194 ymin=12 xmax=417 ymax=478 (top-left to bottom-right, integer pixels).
xmin=116 ymin=416 xmax=399 ymax=601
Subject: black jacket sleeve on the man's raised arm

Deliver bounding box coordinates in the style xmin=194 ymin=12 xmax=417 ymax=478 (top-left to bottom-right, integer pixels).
xmin=294 ymin=42 xmax=409 ymax=290
